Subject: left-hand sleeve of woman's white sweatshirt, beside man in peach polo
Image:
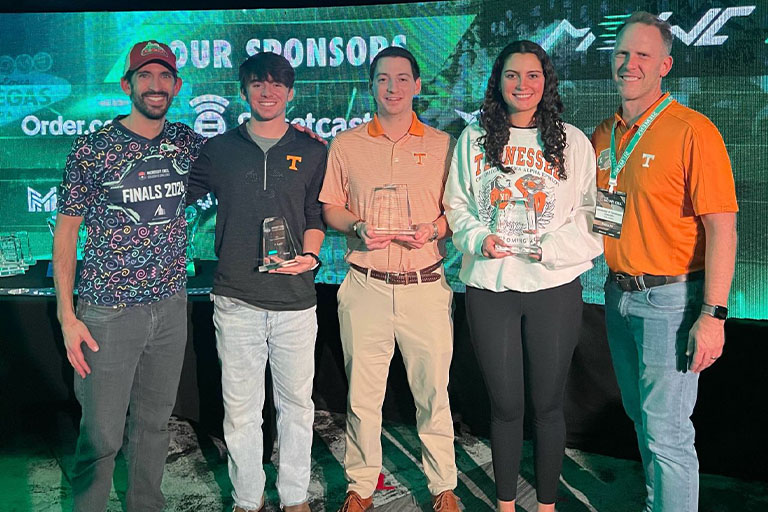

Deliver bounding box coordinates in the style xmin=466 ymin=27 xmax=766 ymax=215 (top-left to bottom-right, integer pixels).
xmin=443 ymin=124 xmax=488 ymax=256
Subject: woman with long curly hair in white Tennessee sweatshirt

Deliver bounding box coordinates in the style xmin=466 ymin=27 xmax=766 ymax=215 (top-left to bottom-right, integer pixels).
xmin=443 ymin=41 xmax=602 ymax=512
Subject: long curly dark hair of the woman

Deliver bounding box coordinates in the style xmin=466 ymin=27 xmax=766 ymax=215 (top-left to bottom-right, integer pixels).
xmin=479 ymin=41 xmax=567 ymax=180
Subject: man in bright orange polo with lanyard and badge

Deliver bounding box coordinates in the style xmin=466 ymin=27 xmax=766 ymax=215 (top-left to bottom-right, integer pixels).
xmin=592 ymin=12 xmax=738 ymax=512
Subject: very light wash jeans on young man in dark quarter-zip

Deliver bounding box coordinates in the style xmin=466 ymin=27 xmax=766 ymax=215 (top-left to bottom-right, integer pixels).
xmin=211 ymin=295 xmax=317 ymax=510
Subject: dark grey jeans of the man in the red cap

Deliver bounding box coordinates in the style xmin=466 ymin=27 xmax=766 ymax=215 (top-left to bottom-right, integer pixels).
xmin=72 ymin=290 xmax=187 ymax=512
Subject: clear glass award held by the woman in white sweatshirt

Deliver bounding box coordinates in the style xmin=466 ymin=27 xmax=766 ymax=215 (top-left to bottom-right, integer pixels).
xmin=494 ymin=196 xmax=540 ymax=254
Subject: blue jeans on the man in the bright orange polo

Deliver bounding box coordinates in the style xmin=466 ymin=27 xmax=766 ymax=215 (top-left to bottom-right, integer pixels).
xmin=605 ymin=280 xmax=704 ymax=512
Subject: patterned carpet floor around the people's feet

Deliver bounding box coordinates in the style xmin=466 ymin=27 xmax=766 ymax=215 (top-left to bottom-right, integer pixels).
xmin=0 ymin=411 xmax=768 ymax=512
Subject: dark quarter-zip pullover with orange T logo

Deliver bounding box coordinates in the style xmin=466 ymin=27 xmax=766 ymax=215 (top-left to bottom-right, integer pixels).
xmin=187 ymin=123 xmax=326 ymax=311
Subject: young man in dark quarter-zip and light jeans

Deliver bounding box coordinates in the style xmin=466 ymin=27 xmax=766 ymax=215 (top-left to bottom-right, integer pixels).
xmin=187 ymin=53 xmax=326 ymax=512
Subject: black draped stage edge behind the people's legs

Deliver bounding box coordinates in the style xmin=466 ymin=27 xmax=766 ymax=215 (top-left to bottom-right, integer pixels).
xmin=0 ymin=262 xmax=768 ymax=481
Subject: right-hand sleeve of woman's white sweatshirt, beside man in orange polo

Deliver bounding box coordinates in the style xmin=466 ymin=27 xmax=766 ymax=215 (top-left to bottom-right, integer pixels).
xmin=541 ymin=127 xmax=603 ymax=269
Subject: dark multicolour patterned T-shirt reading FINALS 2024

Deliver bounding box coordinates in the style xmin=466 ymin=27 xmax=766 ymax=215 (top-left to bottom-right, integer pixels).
xmin=58 ymin=117 xmax=205 ymax=306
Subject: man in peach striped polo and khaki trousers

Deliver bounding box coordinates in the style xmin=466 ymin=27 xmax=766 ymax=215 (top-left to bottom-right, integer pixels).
xmin=320 ymin=47 xmax=458 ymax=512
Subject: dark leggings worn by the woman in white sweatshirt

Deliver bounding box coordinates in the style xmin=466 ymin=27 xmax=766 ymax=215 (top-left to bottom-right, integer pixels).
xmin=466 ymin=279 xmax=583 ymax=504
